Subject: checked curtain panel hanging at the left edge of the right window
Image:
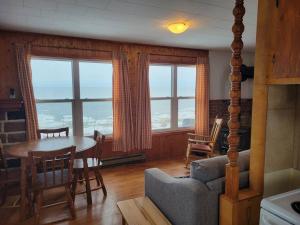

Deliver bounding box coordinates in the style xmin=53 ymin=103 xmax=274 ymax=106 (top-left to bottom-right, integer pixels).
xmin=135 ymin=53 xmax=152 ymax=150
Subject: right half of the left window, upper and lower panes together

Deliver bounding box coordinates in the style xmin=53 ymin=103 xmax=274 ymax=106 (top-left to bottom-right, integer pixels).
xmin=79 ymin=61 xmax=113 ymax=135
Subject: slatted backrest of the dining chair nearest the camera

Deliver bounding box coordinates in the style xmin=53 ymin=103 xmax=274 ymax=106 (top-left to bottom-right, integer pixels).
xmin=28 ymin=146 xmax=76 ymax=188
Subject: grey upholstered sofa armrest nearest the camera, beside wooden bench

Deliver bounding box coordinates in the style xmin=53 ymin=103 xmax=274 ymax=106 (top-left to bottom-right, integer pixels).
xmin=145 ymin=168 xmax=218 ymax=225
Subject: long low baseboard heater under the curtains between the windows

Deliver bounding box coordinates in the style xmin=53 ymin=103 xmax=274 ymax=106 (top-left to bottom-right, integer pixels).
xmin=102 ymin=153 xmax=146 ymax=167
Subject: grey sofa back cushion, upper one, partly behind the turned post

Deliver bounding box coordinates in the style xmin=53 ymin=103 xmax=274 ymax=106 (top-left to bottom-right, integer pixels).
xmin=190 ymin=150 xmax=250 ymax=183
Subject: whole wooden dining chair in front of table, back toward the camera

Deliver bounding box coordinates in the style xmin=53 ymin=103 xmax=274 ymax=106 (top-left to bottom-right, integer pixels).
xmin=28 ymin=146 xmax=76 ymax=224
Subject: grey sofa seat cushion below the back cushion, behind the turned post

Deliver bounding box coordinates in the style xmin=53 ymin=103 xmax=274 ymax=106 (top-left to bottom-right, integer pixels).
xmin=206 ymin=171 xmax=249 ymax=194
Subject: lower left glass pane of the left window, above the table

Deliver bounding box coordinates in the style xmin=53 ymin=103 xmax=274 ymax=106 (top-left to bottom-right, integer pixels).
xmin=36 ymin=102 xmax=73 ymax=135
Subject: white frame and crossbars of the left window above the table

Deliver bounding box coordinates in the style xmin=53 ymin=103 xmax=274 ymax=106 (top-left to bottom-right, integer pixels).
xmin=30 ymin=56 xmax=113 ymax=136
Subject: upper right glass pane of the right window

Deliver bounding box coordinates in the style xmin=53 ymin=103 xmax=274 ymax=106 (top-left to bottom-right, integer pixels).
xmin=177 ymin=66 xmax=196 ymax=96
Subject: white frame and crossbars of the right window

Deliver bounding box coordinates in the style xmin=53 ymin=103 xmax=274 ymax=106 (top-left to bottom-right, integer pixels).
xmin=149 ymin=62 xmax=196 ymax=133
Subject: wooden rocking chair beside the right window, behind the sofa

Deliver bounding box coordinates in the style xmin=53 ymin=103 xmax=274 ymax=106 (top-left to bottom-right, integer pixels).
xmin=185 ymin=117 xmax=223 ymax=167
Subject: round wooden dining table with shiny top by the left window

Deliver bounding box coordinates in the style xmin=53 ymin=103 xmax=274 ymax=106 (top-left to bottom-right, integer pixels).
xmin=6 ymin=136 xmax=97 ymax=220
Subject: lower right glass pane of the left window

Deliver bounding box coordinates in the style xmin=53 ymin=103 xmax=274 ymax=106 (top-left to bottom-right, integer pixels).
xmin=83 ymin=101 xmax=113 ymax=136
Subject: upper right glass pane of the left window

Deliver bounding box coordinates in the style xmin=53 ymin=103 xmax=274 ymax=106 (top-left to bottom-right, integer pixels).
xmin=79 ymin=61 xmax=112 ymax=98
